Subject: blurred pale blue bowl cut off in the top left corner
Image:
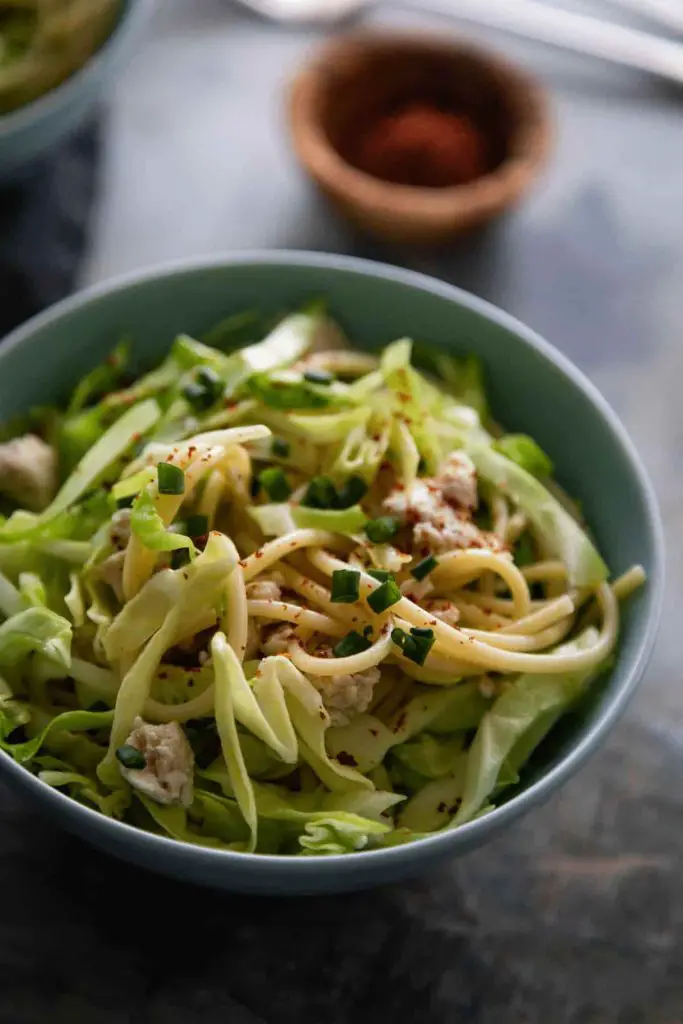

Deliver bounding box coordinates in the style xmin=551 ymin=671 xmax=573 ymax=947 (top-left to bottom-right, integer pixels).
xmin=0 ymin=0 xmax=156 ymax=180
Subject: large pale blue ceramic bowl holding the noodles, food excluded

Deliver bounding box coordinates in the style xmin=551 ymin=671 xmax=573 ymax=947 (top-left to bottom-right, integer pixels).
xmin=0 ymin=252 xmax=664 ymax=894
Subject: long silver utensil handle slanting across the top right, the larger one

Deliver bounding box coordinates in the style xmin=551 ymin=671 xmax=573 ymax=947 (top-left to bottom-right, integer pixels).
xmin=411 ymin=0 xmax=683 ymax=84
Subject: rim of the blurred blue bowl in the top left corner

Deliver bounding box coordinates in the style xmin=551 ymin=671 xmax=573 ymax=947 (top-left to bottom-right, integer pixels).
xmin=0 ymin=0 xmax=157 ymax=140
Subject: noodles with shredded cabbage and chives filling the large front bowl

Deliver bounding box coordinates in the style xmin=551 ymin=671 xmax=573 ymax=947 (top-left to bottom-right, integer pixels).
xmin=0 ymin=306 xmax=644 ymax=856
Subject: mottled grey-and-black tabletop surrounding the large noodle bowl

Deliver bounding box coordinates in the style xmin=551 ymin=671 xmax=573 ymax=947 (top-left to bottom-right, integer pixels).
xmin=5 ymin=0 xmax=683 ymax=1024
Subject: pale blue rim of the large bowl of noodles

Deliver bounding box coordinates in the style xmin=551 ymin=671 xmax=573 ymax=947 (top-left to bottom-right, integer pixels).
xmin=0 ymin=250 xmax=665 ymax=883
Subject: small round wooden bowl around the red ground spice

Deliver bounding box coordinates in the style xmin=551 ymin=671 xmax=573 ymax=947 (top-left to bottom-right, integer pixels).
xmin=289 ymin=34 xmax=551 ymax=244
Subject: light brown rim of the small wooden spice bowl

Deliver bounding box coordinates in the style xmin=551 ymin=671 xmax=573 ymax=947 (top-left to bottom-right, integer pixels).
xmin=288 ymin=30 xmax=553 ymax=219
